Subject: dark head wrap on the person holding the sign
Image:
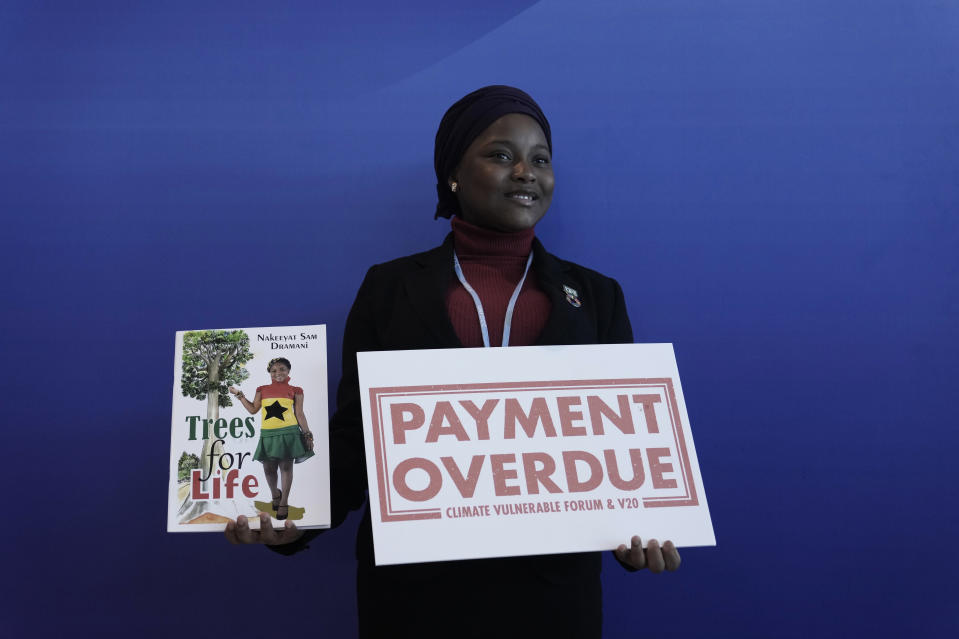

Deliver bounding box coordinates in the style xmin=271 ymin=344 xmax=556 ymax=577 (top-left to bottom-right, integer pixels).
xmin=433 ymin=84 xmax=553 ymax=218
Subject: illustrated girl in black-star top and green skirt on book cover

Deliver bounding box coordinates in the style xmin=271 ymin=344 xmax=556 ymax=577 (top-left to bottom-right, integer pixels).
xmin=230 ymin=357 xmax=313 ymax=520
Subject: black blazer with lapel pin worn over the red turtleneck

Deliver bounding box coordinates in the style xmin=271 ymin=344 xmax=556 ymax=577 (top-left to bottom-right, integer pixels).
xmin=284 ymin=234 xmax=633 ymax=637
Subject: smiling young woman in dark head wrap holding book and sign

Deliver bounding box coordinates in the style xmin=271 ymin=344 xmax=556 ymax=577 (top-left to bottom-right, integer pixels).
xmin=226 ymin=86 xmax=680 ymax=638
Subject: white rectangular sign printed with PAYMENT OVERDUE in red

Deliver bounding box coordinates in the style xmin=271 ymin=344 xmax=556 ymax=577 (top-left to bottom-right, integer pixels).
xmin=357 ymin=344 xmax=716 ymax=565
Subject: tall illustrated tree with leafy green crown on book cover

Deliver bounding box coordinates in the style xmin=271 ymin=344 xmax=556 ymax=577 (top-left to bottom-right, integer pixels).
xmin=180 ymin=330 xmax=253 ymax=521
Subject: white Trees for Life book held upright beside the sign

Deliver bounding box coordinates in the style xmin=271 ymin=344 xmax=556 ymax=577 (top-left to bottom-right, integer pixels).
xmin=167 ymin=325 xmax=330 ymax=532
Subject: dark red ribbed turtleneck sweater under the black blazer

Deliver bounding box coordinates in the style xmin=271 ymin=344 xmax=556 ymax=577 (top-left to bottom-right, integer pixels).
xmin=446 ymin=217 xmax=552 ymax=346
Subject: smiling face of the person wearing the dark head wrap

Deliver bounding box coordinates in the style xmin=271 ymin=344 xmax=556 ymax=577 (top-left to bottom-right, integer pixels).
xmin=450 ymin=113 xmax=553 ymax=231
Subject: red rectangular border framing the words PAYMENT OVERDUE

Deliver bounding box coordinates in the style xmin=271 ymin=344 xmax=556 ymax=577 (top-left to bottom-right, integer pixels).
xmin=370 ymin=377 xmax=699 ymax=521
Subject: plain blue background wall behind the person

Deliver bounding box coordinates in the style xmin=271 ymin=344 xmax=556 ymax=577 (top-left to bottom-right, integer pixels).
xmin=0 ymin=0 xmax=959 ymax=637
